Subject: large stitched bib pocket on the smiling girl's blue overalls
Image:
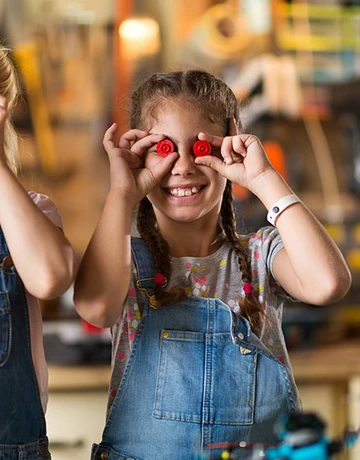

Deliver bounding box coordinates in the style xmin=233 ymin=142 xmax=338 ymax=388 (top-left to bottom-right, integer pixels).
xmin=153 ymin=330 xmax=257 ymax=425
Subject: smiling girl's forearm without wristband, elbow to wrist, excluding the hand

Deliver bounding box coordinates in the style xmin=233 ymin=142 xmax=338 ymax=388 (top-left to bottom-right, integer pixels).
xmin=74 ymin=190 xmax=134 ymax=327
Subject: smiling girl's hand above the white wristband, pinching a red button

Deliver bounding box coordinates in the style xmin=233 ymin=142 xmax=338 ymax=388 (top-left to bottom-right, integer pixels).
xmin=195 ymin=133 xmax=274 ymax=192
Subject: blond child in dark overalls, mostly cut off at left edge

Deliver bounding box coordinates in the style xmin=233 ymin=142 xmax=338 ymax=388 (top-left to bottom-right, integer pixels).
xmin=0 ymin=46 xmax=76 ymax=460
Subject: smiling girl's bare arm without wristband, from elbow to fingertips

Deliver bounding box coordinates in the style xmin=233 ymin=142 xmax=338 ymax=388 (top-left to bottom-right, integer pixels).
xmin=74 ymin=125 xmax=177 ymax=327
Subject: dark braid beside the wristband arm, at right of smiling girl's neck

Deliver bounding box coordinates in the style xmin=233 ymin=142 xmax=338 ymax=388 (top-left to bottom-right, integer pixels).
xmin=220 ymin=181 xmax=264 ymax=331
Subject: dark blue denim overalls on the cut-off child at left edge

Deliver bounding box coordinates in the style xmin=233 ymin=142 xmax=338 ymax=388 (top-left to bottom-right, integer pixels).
xmin=0 ymin=228 xmax=50 ymax=460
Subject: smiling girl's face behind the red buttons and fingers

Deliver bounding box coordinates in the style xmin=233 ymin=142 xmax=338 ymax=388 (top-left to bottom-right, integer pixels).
xmin=145 ymin=101 xmax=226 ymax=228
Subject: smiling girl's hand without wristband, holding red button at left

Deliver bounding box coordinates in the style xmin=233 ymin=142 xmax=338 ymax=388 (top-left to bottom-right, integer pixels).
xmin=103 ymin=123 xmax=178 ymax=206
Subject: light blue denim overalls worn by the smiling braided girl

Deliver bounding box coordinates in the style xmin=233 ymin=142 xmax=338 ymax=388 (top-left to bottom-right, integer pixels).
xmin=92 ymin=239 xmax=295 ymax=460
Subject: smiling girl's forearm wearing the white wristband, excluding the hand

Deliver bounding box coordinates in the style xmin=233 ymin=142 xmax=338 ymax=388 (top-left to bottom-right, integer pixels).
xmin=246 ymin=165 xmax=351 ymax=305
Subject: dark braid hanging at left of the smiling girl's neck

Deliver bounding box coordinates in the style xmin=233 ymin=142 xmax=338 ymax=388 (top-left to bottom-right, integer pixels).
xmin=137 ymin=197 xmax=185 ymax=305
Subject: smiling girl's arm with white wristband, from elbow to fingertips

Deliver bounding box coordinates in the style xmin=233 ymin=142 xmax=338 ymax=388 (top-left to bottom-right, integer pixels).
xmin=196 ymin=134 xmax=351 ymax=305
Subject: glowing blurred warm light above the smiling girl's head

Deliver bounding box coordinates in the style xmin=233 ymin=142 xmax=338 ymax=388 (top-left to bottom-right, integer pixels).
xmin=119 ymin=18 xmax=160 ymax=58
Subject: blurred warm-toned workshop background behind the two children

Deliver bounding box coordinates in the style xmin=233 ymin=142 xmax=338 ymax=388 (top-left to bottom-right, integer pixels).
xmin=0 ymin=0 xmax=360 ymax=460
